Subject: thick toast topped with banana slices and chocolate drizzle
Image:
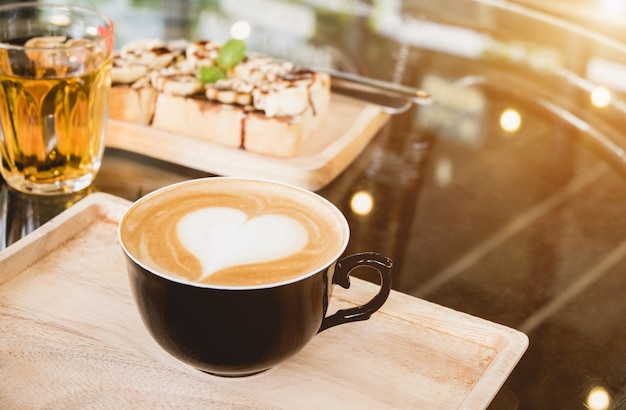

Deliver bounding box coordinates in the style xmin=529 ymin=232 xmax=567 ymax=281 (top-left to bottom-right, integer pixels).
xmin=110 ymin=41 xmax=330 ymax=158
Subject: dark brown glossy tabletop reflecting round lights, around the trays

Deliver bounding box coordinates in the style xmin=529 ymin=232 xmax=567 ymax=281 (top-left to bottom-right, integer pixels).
xmin=0 ymin=0 xmax=626 ymax=409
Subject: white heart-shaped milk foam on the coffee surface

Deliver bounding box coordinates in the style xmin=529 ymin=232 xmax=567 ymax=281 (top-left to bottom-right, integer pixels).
xmin=177 ymin=207 xmax=308 ymax=280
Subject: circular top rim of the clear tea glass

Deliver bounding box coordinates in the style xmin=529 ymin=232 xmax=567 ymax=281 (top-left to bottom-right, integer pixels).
xmin=0 ymin=1 xmax=115 ymax=52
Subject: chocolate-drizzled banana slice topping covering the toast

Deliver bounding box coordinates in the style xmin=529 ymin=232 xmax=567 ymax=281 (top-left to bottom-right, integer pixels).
xmin=113 ymin=40 xmax=324 ymax=117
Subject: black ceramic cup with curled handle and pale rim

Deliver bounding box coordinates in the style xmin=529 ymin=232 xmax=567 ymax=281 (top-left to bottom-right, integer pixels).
xmin=119 ymin=178 xmax=392 ymax=377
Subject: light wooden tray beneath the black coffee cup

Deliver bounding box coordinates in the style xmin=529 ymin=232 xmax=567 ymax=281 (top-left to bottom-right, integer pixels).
xmin=0 ymin=193 xmax=528 ymax=409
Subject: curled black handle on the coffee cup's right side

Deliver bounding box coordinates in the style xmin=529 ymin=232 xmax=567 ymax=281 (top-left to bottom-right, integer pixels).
xmin=318 ymin=252 xmax=393 ymax=333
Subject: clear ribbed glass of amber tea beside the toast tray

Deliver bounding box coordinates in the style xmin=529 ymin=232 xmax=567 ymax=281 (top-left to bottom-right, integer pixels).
xmin=0 ymin=3 xmax=113 ymax=194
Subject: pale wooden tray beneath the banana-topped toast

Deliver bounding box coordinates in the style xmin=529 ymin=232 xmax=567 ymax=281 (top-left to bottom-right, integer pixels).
xmin=106 ymin=94 xmax=389 ymax=190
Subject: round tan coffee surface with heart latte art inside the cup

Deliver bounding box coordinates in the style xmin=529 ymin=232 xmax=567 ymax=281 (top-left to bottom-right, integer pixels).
xmin=120 ymin=178 xmax=348 ymax=287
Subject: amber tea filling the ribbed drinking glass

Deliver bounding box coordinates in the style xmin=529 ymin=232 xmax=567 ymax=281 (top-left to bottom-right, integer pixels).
xmin=0 ymin=60 xmax=110 ymax=192
